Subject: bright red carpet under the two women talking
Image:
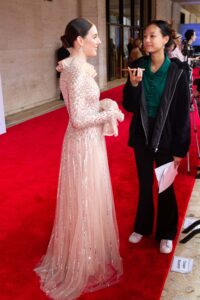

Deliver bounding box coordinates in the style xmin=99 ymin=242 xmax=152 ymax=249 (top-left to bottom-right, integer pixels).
xmin=0 ymin=87 xmax=197 ymax=300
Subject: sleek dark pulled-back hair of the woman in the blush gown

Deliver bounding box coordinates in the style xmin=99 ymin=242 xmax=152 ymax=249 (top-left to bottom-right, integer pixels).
xmin=63 ymin=18 xmax=93 ymax=48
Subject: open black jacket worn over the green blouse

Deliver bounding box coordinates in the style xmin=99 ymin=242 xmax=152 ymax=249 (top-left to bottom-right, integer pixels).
xmin=122 ymin=57 xmax=190 ymax=157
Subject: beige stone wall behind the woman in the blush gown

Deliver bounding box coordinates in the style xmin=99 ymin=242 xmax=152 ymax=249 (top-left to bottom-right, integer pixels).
xmin=0 ymin=0 xmax=106 ymax=115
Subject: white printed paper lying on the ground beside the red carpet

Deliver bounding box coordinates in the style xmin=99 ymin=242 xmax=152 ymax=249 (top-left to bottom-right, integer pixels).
xmin=171 ymin=256 xmax=193 ymax=273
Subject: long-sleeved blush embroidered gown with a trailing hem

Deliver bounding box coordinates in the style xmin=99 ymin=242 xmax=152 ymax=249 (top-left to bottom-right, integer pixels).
xmin=35 ymin=57 xmax=123 ymax=300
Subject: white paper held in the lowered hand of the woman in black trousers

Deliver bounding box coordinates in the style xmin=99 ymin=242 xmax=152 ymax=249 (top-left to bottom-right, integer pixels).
xmin=155 ymin=161 xmax=178 ymax=193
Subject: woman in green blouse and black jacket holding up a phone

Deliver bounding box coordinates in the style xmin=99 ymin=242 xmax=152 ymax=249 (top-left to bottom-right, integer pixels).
xmin=122 ymin=20 xmax=190 ymax=254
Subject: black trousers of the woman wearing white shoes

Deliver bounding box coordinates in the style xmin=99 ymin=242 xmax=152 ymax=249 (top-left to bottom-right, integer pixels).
xmin=134 ymin=144 xmax=178 ymax=240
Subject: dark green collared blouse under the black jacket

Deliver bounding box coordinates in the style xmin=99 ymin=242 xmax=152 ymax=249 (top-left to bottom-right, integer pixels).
xmin=143 ymin=55 xmax=171 ymax=117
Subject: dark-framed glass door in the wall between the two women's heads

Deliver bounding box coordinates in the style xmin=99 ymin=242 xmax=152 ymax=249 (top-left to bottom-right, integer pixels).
xmin=106 ymin=0 xmax=151 ymax=80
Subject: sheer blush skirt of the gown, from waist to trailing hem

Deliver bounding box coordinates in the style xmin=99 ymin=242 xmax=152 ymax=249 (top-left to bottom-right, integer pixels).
xmin=35 ymin=128 xmax=122 ymax=300
